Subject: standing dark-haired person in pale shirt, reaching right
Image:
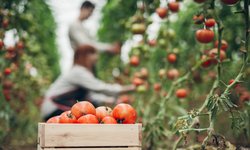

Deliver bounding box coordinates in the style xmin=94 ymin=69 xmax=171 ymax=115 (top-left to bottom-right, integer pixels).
xmin=68 ymin=1 xmax=120 ymax=54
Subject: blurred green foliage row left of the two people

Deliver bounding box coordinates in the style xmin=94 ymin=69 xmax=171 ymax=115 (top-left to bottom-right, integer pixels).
xmin=0 ymin=0 xmax=60 ymax=148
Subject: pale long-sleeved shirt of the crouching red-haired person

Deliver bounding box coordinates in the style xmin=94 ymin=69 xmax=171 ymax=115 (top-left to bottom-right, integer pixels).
xmin=41 ymin=65 xmax=122 ymax=117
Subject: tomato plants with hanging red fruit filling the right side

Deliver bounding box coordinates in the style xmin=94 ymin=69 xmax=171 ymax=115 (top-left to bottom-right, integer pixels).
xmin=96 ymin=0 xmax=250 ymax=149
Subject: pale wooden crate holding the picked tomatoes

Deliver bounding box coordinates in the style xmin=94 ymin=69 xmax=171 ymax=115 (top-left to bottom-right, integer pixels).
xmin=38 ymin=123 xmax=142 ymax=150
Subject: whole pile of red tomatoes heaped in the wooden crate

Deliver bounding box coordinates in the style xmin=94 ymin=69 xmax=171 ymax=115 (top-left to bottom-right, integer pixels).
xmin=46 ymin=101 xmax=137 ymax=124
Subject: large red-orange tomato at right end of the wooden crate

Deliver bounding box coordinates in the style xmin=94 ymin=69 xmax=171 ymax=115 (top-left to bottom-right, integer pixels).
xmin=112 ymin=103 xmax=137 ymax=124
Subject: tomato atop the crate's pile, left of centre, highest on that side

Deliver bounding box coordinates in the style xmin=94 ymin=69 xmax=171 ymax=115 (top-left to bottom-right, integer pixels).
xmin=71 ymin=101 xmax=96 ymax=119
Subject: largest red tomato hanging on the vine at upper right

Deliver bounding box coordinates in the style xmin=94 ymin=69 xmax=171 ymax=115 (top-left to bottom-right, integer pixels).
xmin=196 ymin=29 xmax=214 ymax=43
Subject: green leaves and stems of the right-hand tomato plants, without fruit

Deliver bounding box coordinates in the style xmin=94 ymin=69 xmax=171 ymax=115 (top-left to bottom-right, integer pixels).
xmin=99 ymin=0 xmax=250 ymax=149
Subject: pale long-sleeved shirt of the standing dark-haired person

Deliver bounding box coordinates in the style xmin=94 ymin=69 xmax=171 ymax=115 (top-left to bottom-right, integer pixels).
xmin=68 ymin=19 xmax=112 ymax=51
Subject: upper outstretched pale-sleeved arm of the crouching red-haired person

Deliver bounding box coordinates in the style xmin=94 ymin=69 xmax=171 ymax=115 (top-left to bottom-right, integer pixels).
xmin=69 ymin=66 xmax=134 ymax=96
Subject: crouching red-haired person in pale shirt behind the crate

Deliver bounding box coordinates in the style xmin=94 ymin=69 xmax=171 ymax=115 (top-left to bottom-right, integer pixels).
xmin=41 ymin=45 xmax=135 ymax=120
